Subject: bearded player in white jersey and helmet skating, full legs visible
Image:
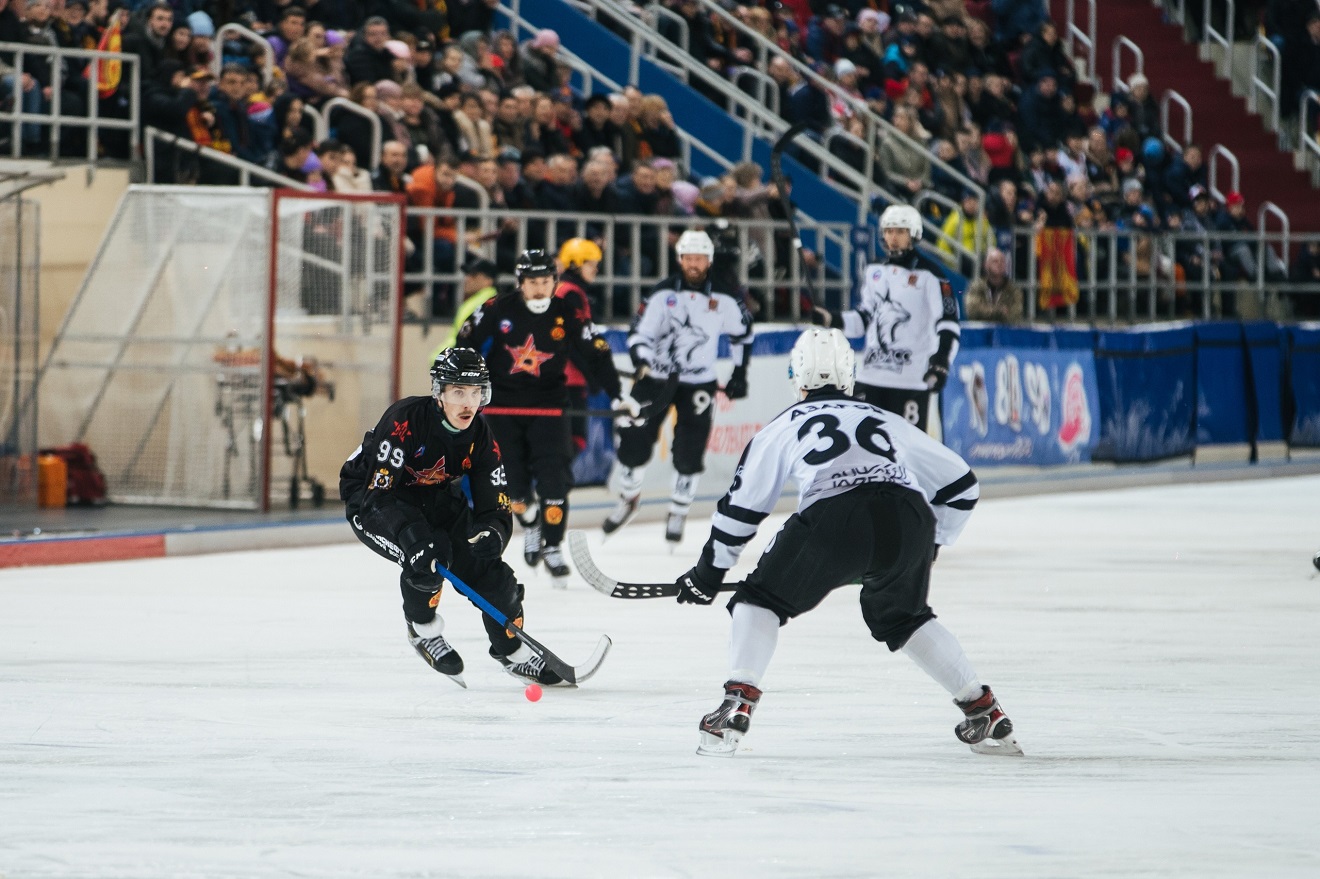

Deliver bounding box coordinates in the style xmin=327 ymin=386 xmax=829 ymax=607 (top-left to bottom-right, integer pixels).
xmin=603 ymin=231 xmax=752 ymax=542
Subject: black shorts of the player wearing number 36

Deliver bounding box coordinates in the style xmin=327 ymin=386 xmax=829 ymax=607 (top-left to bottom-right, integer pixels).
xmin=729 ymin=483 xmax=935 ymax=651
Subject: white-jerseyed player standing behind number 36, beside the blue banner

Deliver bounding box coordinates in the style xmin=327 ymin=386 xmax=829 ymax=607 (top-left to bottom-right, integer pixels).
xmin=826 ymin=205 xmax=958 ymax=430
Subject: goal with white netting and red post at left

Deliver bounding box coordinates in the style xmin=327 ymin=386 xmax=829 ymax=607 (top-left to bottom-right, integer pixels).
xmin=40 ymin=186 xmax=403 ymax=509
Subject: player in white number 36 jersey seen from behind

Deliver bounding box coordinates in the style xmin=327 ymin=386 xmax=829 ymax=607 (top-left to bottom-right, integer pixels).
xmin=677 ymin=327 xmax=1022 ymax=756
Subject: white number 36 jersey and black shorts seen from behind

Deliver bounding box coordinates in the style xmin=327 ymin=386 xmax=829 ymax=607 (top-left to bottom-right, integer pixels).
xmin=702 ymin=389 xmax=979 ymax=649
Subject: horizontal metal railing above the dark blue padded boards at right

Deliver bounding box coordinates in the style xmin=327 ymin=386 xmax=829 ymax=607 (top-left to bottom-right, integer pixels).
xmin=1007 ymin=224 xmax=1304 ymax=323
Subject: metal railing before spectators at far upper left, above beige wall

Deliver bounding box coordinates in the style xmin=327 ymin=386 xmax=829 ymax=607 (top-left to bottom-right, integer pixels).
xmin=0 ymin=42 xmax=143 ymax=162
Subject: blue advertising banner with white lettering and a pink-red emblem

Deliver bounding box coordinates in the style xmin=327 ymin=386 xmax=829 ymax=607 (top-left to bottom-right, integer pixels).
xmin=942 ymin=348 xmax=1100 ymax=467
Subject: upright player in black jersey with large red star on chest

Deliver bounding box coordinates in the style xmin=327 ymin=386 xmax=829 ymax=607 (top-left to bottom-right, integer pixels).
xmin=458 ymin=251 xmax=640 ymax=589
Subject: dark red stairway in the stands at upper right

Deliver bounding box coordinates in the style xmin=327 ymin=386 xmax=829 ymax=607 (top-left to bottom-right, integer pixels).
xmin=1049 ymin=0 xmax=1320 ymax=232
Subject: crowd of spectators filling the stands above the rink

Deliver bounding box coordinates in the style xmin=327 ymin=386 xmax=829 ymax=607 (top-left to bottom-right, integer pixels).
xmin=0 ymin=0 xmax=1320 ymax=318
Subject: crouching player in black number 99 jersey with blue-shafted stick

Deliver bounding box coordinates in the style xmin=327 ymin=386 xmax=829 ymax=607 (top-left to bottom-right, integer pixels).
xmin=339 ymin=348 xmax=561 ymax=688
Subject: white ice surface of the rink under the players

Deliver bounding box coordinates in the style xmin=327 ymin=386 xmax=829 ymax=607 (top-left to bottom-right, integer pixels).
xmin=0 ymin=476 xmax=1320 ymax=879
